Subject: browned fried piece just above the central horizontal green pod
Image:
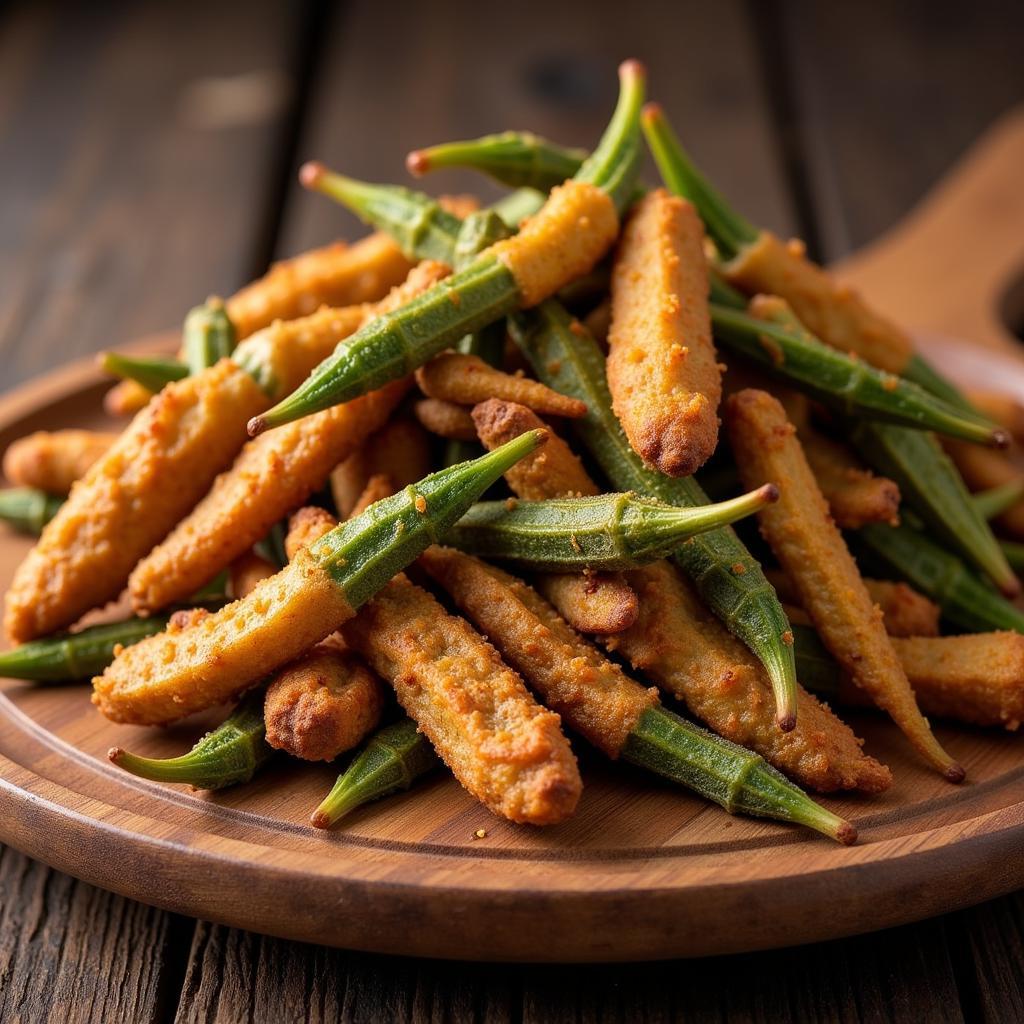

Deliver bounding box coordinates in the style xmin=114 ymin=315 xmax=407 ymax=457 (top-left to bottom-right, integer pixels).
xmin=472 ymin=398 xmax=601 ymax=501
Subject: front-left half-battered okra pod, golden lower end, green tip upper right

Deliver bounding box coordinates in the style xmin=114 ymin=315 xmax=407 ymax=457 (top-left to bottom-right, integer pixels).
xmin=93 ymin=430 xmax=544 ymax=724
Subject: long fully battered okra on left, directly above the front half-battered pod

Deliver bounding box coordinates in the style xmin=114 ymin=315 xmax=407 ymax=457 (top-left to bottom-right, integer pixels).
xmin=128 ymin=381 xmax=408 ymax=611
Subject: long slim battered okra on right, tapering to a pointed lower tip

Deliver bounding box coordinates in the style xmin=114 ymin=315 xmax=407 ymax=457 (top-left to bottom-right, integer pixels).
xmin=725 ymin=390 xmax=965 ymax=782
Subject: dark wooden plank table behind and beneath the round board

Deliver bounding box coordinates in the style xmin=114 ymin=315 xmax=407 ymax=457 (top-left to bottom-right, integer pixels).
xmin=0 ymin=0 xmax=1024 ymax=1022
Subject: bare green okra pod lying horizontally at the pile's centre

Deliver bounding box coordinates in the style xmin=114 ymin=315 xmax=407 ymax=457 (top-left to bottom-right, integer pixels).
xmin=444 ymin=483 xmax=778 ymax=572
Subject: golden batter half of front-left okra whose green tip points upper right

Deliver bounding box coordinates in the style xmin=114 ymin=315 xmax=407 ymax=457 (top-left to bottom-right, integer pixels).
xmin=92 ymin=550 xmax=353 ymax=725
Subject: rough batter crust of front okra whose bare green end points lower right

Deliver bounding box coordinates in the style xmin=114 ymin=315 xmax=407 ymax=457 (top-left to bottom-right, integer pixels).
xmin=420 ymin=547 xmax=657 ymax=758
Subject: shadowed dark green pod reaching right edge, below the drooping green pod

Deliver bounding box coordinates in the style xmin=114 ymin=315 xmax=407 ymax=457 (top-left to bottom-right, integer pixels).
xmin=848 ymin=522 xmax=1024 ymax=633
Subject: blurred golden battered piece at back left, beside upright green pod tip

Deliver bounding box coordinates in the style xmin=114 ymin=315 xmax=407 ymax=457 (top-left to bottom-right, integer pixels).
xmin=225 ymin=231 xmax=412 ymax=338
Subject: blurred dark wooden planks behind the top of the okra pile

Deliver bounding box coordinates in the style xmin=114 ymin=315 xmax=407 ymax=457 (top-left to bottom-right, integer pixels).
xmin=0 ymin=0 xmax=1024 ymax=387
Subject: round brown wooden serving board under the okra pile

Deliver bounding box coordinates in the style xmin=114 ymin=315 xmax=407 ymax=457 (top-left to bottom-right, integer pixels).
xmin=0 ymin=110 xmax=1024 ymax=961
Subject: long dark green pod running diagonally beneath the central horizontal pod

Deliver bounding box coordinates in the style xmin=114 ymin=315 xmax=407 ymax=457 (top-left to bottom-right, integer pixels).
xmin=509 ymin=301 xmax=797 ymax=728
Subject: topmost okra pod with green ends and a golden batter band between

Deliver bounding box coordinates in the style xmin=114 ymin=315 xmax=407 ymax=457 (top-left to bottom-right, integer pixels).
xmin=249 ymin=61 xmax=644 ymax=435
